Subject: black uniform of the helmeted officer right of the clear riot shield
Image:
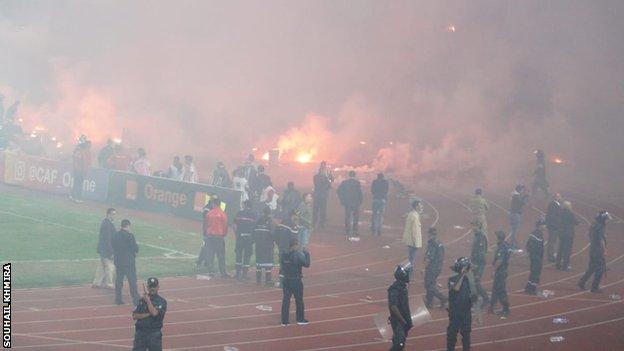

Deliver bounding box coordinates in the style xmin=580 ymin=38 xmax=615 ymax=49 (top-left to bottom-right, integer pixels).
xmin=446 ymin=275 xmax=476 ymax=351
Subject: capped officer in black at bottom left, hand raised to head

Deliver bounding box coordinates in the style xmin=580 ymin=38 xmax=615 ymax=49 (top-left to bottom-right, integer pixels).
xmin=132 ymin=278 xmax=167 ymax=351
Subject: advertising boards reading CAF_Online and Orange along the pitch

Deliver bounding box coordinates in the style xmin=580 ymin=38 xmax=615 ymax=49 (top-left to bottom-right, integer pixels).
xmin=0 ymin=151 xmax=242 ymax=220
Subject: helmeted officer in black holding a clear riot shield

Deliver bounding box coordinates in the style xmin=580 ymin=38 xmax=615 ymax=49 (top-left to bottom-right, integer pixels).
xmin=388 ymin=265 xmax=414 ymax=351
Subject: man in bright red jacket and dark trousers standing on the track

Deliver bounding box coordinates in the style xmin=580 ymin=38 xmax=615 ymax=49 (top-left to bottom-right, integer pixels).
xmin=204 ymin=198 xmax=230 ymax=278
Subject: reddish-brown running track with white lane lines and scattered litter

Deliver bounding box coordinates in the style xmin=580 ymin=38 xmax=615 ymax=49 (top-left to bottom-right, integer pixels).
xmin=13 ymin=191 xmax=624 ymax=351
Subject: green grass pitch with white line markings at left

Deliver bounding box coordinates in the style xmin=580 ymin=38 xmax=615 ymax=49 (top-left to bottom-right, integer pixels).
xmin=0 ymin=188 xmax=245 ymax=288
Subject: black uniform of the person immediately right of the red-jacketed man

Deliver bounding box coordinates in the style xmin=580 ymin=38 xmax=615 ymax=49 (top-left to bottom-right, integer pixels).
xmin=234 ymin=209 xmax=258 ymax=279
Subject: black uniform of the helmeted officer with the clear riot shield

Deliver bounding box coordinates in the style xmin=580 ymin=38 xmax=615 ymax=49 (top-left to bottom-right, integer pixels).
xmin=388 ymin=281 xmax=413 ymax=351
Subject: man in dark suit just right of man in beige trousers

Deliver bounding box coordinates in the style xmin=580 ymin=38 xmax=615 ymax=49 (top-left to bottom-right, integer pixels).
xmin=111 ymin=219 xmax=139 ymax=305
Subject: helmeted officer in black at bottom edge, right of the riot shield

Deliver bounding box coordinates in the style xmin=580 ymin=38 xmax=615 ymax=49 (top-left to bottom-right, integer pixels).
xmin=446 ymin=257 xmax=476 ymax=351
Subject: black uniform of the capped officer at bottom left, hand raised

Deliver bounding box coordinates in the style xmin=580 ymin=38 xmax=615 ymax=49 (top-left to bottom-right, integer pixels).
xmin=132 ymin=294 xmax=167 ymax=351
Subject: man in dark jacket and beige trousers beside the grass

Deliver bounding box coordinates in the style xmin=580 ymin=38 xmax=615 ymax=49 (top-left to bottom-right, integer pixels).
xmin=92 ymin=208 xmax=117 ymax=289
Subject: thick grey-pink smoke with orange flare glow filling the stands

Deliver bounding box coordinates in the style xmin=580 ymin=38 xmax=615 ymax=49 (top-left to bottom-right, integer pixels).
xmin=0 ymin=0 xmax=624 ymax=191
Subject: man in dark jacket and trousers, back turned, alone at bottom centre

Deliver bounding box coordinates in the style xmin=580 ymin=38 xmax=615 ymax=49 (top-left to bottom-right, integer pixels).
xmin=280 ymin=238 xmax=310 ymax=327
